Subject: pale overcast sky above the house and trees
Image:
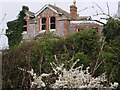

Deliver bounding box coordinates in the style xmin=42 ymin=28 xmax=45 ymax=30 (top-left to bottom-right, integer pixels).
xmin=0 ymin=0 xmax=120 ymax=49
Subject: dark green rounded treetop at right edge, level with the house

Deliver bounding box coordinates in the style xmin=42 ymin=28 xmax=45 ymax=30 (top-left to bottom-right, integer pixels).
xmin=103 ymin=18 xmax=120 ymax=41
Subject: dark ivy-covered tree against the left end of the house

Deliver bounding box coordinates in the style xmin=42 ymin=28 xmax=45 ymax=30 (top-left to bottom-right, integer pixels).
xmin=6 ymin=6 xmax=29 ymax=46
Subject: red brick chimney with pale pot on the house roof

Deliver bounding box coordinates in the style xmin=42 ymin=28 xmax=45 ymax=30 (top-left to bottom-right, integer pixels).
xmin=70 ymin=0 xmax=78 ymax=19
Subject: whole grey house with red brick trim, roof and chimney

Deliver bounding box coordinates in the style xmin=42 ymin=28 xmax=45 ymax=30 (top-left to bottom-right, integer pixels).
xmin=23 ymin=5 xmax=103 ymax=40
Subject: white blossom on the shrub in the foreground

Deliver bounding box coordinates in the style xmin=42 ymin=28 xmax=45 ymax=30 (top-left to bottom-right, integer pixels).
xmin=19 ymin=60 xmax=118 ymax=88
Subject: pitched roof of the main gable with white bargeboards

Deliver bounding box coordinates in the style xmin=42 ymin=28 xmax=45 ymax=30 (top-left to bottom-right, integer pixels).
xmin=35 ymin=4 xmax=70 ymax=18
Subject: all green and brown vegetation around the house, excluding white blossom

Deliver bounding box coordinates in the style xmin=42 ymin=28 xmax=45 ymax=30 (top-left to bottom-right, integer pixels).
xmin=3 ymin=6 xmax=120 ymax=89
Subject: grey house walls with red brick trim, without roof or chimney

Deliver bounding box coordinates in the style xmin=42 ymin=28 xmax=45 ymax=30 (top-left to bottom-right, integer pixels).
xmin=23 ymin=7 xmax=101 ymax=39
